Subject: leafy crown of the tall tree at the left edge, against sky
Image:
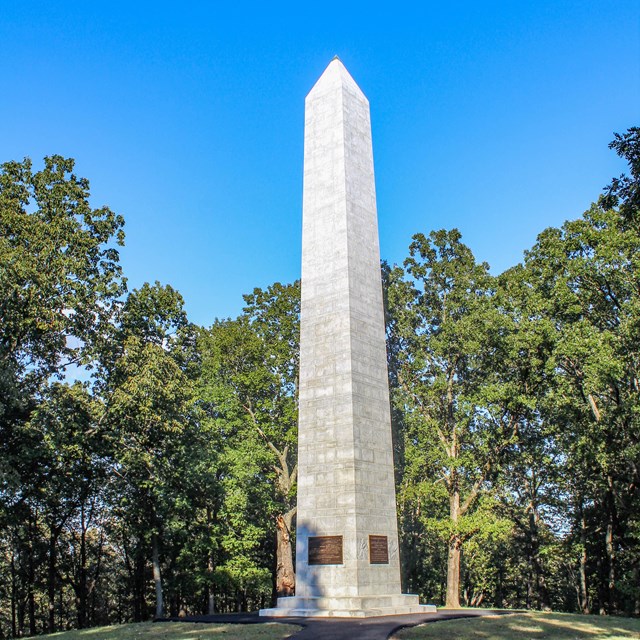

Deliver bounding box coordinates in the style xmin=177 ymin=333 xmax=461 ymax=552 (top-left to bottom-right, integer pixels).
xmin=0 ymin=156 xmax=124 ymax=425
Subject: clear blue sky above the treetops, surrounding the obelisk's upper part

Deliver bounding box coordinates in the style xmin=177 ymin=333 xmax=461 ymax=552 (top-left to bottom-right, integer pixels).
xmin=0 ymin=0 xmax=640 ymax=325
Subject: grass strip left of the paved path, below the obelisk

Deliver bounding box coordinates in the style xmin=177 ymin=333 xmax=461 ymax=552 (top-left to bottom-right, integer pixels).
xmin=40 ymin=622 xmax=300 ymax=640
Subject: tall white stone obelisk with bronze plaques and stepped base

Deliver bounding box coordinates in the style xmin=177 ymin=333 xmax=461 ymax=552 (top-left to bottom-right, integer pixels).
xmin=261 ymin=58 xmax=433 ymax=617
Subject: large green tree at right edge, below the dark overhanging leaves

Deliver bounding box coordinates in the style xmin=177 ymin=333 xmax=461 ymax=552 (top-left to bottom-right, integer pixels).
xmin=526 ymin=208 xmax=640 ymax=612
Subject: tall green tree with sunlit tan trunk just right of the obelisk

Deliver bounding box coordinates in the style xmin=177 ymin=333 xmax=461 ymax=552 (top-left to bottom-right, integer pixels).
xmin=388 ymin=230 xmax=520 ymax=607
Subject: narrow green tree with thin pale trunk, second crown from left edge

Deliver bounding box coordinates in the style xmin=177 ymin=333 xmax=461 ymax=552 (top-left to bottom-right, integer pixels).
xmin=104 ymin=282 xmax=196 ymax=619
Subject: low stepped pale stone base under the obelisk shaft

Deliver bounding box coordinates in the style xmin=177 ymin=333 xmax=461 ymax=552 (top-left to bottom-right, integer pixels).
xmin=260 ymin=594 xmax=436 ymax=618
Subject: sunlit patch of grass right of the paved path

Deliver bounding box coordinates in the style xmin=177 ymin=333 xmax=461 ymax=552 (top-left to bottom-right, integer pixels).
xmin=394 ymin=612 xmax=640 ymax=640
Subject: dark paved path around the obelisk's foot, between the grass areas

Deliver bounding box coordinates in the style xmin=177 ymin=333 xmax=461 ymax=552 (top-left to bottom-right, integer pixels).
xmin=160 ymin=609 xmax=505 ymax=640
